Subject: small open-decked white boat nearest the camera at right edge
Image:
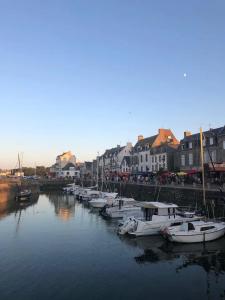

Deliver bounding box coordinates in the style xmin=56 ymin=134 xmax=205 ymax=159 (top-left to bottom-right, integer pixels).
xmin=163 ymin=221 xmax=225 ymax=243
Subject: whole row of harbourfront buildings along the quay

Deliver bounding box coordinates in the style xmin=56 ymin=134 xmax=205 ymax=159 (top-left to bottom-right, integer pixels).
xmin=50 ymin=126 xmax=225 ymax=177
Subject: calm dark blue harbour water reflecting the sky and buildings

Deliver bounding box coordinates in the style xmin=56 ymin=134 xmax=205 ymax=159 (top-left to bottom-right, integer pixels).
xmin=0 ymin=193 xmax=225 ymax=300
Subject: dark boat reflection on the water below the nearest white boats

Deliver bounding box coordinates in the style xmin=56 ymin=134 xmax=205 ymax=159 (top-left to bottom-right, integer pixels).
xmin=132 ymin=237 xmax=225 ymax=275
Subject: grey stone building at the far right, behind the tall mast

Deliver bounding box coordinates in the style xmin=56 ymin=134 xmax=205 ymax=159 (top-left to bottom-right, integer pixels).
xmin=178 ymin=126 xmax=225 ymax=171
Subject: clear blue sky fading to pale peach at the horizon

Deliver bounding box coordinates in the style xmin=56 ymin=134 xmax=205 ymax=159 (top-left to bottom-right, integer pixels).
xmin=0 ymin=0 xmax=225 ymax=168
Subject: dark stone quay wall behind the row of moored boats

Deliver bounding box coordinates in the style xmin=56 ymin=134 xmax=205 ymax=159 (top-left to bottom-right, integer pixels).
xmin=85 ymin=182 xmax=225 ymax=218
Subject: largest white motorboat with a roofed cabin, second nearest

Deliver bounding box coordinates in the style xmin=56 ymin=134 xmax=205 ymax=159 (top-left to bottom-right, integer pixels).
xmin=118 ymin=202 xmax=199 ymax=236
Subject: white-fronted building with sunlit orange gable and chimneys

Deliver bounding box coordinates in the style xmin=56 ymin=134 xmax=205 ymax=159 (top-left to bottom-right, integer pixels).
xmin=132 ymin=128 xmax=179 ymax=173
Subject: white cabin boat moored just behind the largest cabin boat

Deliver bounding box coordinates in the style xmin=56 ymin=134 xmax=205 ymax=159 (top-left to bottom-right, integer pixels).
xmin=101 ymin=198 xmax=142 ymax=219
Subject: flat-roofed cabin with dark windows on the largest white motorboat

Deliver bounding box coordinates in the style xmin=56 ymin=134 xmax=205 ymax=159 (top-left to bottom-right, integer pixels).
xmin=137 ymin=202 xmax=178 ymax=221
